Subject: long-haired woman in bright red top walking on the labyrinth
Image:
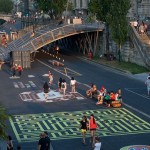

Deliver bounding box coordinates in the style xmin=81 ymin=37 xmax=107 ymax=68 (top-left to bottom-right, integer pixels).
xmin=89 ymin=114 xmax=97 ymax=147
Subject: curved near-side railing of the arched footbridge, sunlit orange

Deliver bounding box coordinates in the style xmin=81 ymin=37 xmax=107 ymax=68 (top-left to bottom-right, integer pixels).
xmin=21 ymin=24 xmax=104 ymax=51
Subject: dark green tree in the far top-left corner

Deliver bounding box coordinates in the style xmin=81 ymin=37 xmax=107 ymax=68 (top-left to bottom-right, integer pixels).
xmin=0 ymin=0 xmax=13 ymax=14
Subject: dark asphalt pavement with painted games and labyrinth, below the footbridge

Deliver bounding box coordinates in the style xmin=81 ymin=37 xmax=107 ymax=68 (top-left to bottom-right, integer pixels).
xmin=0 ymin=52 xmax=150 ymax=150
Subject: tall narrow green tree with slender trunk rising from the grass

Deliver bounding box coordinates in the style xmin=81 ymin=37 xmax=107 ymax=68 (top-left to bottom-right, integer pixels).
xmin=107 ymin=0 xmax=130 ymax=62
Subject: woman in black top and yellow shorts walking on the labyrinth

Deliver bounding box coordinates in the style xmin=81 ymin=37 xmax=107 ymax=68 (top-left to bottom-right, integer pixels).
xmin=80 ymin=116 xmax=88 ymax=144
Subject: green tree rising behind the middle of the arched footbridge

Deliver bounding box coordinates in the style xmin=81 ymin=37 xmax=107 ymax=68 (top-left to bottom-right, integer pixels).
xmin=35 ymin=0 xmax=73 ymax=18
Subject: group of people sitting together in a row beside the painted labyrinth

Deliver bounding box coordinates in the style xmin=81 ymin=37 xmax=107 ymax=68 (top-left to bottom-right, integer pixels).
xmin=86 ymin=84 xmax=122 ymax=107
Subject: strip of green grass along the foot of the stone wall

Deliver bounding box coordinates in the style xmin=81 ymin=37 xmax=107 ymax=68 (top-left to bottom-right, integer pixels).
xmin=93 ymin=57 xmax=150 ymax=74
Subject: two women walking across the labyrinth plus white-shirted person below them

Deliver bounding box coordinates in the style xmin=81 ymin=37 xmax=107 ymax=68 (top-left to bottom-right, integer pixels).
xmin=80 ymin=114 xmax=101 ymax=150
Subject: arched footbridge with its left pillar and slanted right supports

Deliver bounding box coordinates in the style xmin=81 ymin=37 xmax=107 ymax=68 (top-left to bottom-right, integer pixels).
xmin=5 ymin=24 xmax=104 ymax=68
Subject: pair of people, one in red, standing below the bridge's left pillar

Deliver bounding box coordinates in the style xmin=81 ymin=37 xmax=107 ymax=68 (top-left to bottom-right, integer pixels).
xmin=11 ymin=64 xmax=23 ymax=77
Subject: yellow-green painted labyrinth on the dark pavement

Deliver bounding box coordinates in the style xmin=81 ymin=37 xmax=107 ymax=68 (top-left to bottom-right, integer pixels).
xmin=10 ymin=108 xmax=150 ymax=142
